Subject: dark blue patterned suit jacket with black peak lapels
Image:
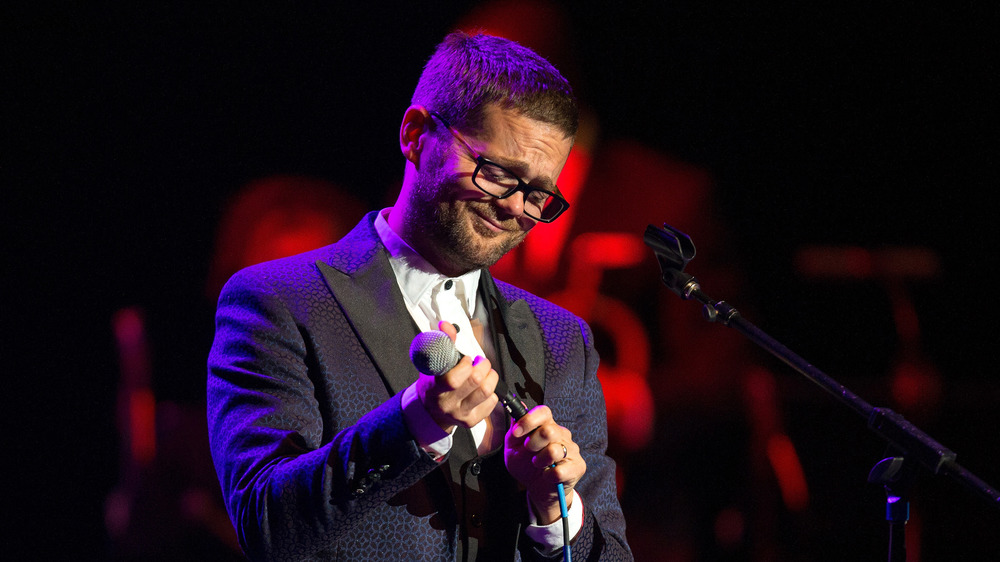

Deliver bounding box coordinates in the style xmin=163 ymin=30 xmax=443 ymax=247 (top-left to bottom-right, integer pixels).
xmin=208 ymin=213 xmax=631 ymax=561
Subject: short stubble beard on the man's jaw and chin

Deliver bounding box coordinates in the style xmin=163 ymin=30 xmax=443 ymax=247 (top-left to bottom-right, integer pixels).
xmin=406 ymin=148 xmax=527 ymax=274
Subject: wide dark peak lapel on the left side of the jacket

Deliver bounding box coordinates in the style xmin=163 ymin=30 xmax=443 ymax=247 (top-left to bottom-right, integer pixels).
xmin=316 ymin=213 xmax=417 ymax=395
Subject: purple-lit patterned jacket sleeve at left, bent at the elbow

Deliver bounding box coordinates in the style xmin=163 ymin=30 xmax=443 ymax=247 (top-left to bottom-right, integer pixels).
xmin=207 ymin=272 xmax=436 ymax=560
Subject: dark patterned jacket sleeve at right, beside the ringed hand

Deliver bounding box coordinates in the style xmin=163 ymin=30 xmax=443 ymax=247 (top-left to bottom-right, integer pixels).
xmin=521 ymin=318 xmax=633 ymax=562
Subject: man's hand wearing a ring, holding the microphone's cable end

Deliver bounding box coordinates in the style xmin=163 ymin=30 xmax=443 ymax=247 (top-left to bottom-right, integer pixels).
xmin=504 ymin=406 xmax=587 ymax=525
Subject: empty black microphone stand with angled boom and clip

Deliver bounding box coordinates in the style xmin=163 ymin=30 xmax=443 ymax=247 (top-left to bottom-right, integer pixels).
xmin=643 ymin=224 xmax=1000 ymax=562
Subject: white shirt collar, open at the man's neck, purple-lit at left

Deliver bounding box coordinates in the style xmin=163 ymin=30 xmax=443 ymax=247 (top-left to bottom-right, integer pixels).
xmin=375 ymin=207 xmax=482 ymax=317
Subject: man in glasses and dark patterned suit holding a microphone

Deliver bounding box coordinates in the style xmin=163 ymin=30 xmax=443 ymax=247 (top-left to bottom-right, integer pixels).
xmin=208 ymin=33 xmax=631 ymax=560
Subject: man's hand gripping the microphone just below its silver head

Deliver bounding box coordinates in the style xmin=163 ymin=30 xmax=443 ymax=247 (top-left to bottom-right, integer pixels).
xmin=416 ymin=322 xmax=498 ymax=430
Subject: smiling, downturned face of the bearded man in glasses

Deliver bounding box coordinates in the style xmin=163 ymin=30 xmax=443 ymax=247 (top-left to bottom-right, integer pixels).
xmin=398 ymin=107 xmax=573 ymax=275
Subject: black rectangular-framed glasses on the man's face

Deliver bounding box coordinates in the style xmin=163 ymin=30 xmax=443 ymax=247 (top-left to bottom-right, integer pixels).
xmin=429 ymin=111 xmax=569 ymax=222
